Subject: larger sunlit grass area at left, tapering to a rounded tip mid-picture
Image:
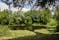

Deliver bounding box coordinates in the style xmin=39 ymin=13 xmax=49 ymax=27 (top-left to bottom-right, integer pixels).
xmin=0 ymin=25 xmax=35 ymax=39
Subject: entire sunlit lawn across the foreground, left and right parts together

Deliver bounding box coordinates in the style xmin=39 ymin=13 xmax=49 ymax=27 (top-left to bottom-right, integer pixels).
xmin=0 ymin=26 xmax=59 ymax=40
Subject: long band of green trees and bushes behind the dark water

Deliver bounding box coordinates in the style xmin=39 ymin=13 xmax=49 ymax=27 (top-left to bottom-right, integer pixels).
xmin=0 ymin=7 xmax=59 ymax=31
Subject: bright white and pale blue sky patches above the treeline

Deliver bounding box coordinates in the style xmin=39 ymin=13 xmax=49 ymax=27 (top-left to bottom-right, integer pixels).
xmin=0 ymin=0 xmax=30 ymax=12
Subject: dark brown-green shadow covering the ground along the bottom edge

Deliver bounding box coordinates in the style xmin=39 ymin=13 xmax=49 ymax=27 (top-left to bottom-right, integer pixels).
xmin=8 ymin=32 xmax=59 ymax=40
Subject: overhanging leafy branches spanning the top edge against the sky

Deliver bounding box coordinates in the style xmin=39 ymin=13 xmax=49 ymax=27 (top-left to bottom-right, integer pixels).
xmin=2 ymin=0 xmax=55 ymax=10
